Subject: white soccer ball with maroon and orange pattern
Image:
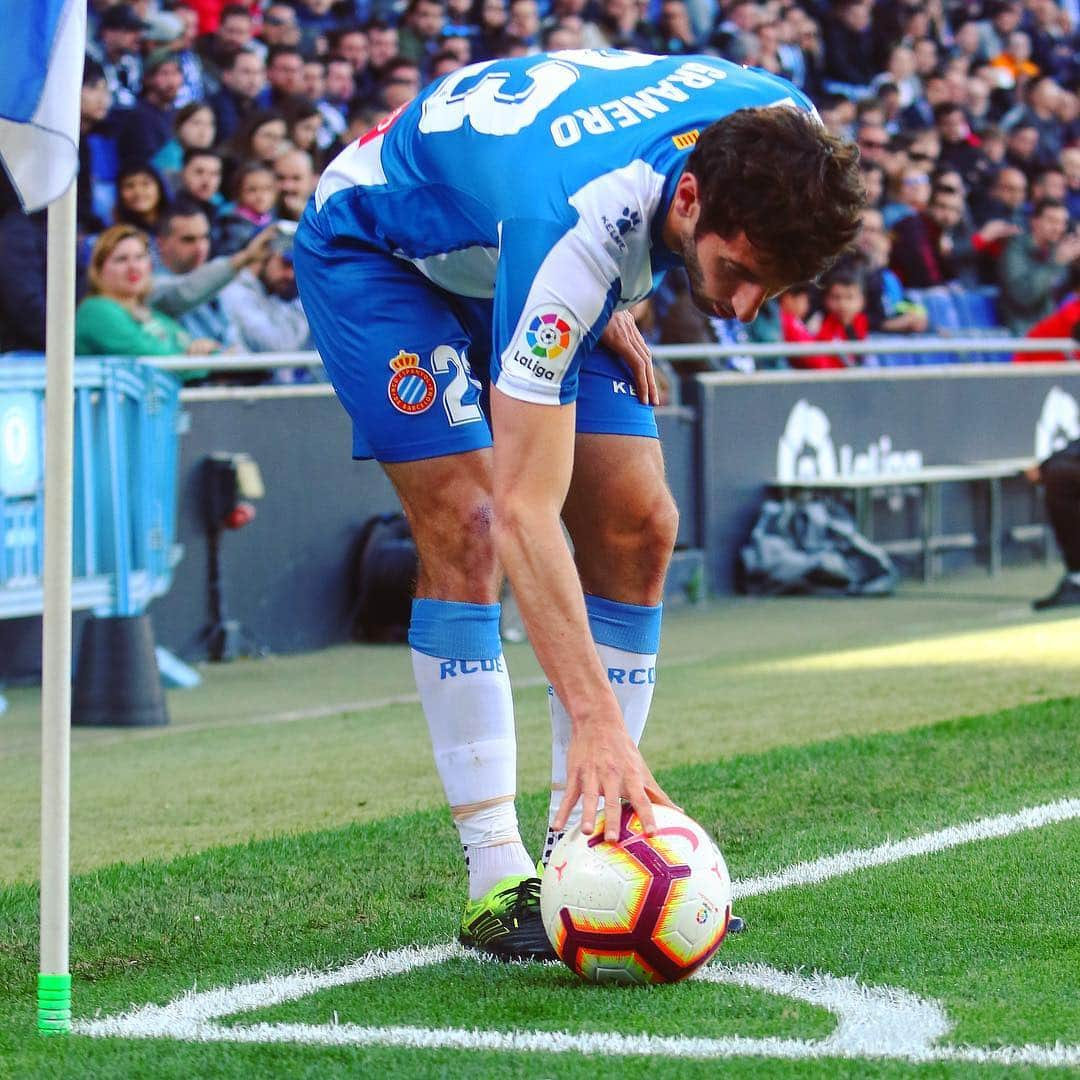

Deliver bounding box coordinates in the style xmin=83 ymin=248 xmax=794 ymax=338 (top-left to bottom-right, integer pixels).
xmin=540 ymin=805 xmax=731 ymax=983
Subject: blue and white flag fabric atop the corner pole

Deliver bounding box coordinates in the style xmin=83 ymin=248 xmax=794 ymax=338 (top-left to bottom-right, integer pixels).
xmin=0 ymin=0 xmax=86 ymax=213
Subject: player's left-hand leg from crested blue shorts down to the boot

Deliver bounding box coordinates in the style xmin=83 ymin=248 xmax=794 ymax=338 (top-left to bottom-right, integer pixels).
xmin=296 ymin=224 xmax=551 ymax=956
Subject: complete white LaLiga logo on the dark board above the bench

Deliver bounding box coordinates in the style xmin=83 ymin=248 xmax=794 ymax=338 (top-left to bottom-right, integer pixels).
xmin=777 ymin=400 xmax=922 ymax=484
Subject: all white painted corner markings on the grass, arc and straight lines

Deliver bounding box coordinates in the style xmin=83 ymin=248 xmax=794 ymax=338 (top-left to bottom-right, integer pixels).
xmin=73 ymin=798 xmax=1080 ymax=1067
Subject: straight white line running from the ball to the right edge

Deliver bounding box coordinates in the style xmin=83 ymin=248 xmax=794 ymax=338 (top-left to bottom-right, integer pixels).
xmin=731 ymin=798 xmax=1080 ymax=900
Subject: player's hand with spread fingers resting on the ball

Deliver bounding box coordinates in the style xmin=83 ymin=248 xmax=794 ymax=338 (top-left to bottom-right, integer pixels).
xmin=552 ymin=716 xmax=675 ymax=840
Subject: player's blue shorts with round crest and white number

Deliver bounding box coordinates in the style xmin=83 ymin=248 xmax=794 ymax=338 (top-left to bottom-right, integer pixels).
xmin=294 ymin=206 xmax=657 ymax=461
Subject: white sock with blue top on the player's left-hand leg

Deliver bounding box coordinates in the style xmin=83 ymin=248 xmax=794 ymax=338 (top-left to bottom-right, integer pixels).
xmin=409 ymin=599 xmax=535 ymax=900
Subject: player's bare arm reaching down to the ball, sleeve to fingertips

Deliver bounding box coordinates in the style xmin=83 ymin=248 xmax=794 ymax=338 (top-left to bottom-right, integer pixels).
xmin=491 ymin=389 xmax=670 ymax=839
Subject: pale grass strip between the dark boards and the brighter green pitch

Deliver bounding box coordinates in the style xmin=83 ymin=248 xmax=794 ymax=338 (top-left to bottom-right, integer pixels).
xmin=0 ymin=567 xmax=1080 ymax=881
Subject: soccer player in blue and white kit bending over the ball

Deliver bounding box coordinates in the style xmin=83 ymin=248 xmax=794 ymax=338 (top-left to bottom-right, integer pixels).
xmin=295 ymin=50 xmax=863 ymax=957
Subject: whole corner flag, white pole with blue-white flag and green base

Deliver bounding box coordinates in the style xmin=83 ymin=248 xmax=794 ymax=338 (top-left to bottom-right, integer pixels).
xmin=0 ymin=0 xmax=86 ymax=1035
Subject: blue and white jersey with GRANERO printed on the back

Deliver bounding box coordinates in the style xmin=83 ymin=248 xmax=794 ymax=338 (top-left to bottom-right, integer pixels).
xmin=314 ymin=50 xmax=813 ymax=404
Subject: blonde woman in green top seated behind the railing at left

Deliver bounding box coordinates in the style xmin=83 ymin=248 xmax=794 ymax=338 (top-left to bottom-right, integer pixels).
xmin=75 ymin=225 xmax=220 ymax=381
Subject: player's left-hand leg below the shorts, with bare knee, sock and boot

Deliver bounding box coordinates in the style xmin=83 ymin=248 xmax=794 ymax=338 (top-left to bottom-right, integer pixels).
xmin=384 ymin=450 xmax=551 ymax=957
